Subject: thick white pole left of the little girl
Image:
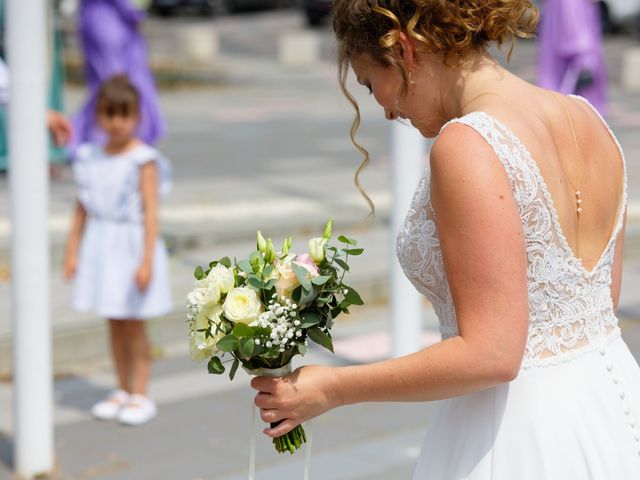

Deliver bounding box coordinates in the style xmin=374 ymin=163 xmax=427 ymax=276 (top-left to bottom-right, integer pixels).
xmin=6 ymin=0 xmax=54 ymax=478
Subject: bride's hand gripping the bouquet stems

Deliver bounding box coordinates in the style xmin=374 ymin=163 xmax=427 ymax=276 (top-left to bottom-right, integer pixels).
xmin=251 ymin=365 xmax=338 ymax=438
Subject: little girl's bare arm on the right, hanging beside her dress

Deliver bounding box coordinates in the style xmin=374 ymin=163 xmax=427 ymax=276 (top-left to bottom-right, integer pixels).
xmin=136 ymin=161 xmax=158 ymax=290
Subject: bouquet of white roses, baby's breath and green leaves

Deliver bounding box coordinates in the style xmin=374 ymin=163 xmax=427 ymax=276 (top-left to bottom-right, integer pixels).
xmin=187 ymin=220 xmax=363 ymax=453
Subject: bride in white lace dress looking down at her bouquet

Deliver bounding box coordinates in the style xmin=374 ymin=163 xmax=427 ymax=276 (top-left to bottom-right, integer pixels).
xmin=252 ymin=0 xmax=640 ymax=480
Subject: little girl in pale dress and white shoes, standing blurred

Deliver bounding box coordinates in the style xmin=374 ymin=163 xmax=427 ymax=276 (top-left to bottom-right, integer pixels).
xmin=64 ymin=75 xmax=172 ymax=425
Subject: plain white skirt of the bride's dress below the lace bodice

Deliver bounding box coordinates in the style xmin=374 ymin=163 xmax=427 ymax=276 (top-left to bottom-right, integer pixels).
xmin=413 ymin=329 xmax=640 ymax=480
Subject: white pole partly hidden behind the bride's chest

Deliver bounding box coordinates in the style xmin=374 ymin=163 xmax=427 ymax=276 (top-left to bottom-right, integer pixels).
xmin=390 ymin=122 xmax=427 ymax=357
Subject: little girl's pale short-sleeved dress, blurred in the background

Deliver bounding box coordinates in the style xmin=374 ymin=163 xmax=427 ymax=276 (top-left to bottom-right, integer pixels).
xmin=73 ymin=144 xmax=173 ymax=319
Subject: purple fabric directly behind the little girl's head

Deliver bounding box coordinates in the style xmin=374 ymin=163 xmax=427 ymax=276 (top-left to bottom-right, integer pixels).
xmin=70 ymin=0 xmax=166 ymax=154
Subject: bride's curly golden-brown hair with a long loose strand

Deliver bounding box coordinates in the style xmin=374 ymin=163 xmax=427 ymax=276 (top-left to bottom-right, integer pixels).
xmin=333 ymin=0 xmax=539 ymax=211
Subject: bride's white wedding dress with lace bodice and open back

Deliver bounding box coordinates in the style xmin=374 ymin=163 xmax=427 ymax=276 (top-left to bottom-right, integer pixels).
xmin=397 ymin=97 xmax=640 ymax=480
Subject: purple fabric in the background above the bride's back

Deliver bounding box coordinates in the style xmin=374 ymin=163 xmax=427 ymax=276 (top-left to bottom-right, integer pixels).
xmin=538 ymin=0 xmax=607 ymax=114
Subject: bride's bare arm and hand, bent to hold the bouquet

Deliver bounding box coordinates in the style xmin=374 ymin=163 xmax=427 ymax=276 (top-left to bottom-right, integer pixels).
xmin=252 ymin=124 xmax=529 ymax=437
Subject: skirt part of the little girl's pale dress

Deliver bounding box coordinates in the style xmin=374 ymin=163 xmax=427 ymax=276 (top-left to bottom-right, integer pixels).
xmin=73 ymin=219 xmax=173 ymax=320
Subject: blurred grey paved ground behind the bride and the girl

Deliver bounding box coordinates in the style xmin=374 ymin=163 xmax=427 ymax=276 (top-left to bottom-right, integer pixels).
xmin=0 ymin=8 xmax=640 ymax=480
